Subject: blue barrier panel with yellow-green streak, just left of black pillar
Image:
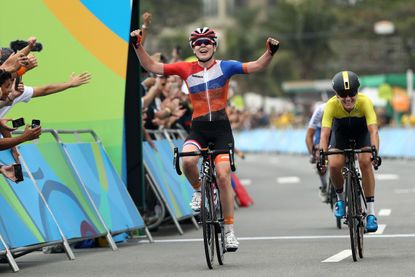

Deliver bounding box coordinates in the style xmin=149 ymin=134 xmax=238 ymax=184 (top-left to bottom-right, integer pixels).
xmin=63 ymin=143 xmax=145 ymax=234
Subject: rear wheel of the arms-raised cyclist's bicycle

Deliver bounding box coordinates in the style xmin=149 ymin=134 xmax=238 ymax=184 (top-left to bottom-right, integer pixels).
xmin=213 ymin=184 xmax=225 ymax=265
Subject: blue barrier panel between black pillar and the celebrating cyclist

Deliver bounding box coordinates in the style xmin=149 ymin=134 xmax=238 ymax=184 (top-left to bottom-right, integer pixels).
xmin=143 ymin=141 xmax=193 ymax=220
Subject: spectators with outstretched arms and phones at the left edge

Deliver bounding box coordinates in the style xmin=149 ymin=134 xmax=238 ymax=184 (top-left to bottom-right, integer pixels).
xmin=0 ymin=37 xmax=91 ymax=182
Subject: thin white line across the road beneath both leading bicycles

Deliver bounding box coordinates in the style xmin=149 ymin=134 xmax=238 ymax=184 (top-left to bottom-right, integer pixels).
xmin=149 ymin=232 xmax=415 ymax=243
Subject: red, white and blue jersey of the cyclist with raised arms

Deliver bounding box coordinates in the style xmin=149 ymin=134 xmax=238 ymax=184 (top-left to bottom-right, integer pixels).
xmin=163 ymin=60 xmax=248 ymax=121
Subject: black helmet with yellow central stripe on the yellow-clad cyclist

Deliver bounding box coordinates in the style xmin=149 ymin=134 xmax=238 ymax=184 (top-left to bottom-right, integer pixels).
xmin=332 ymin=71 xmax=360 ymax=97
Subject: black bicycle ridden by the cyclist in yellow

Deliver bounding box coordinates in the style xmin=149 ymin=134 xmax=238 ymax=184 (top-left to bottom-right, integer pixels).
xmin=319 ymin=146 xmax=382 ymax=262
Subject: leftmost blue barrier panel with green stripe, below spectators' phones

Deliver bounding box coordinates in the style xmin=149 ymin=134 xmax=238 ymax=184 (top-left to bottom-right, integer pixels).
xmin=0 ymin=150 xmax=62 ymax=249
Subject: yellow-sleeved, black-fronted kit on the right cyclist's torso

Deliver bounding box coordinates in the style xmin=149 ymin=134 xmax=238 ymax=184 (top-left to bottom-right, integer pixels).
xmin=322 ymin=93 xmax=377 ymax=149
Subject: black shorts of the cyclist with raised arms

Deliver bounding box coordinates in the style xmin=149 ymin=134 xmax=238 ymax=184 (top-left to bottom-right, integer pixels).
xmin=185 ymin=120 xmax=234 ymax=150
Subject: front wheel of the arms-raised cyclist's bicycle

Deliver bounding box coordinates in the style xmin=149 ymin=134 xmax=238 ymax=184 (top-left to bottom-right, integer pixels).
xmin=200 ymin=178 xmax=215 ymax=269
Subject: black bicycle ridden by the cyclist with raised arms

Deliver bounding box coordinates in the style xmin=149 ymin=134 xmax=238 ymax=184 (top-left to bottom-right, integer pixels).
xmin=174 ymin=143 xmax=235 ymax=269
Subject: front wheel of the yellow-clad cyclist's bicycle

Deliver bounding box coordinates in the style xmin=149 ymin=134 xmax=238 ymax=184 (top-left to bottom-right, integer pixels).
xmin=346 ymin=174 xmax=358 ymax=262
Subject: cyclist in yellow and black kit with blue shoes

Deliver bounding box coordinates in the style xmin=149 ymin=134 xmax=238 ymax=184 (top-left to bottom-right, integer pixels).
xmin=320 ymin=71 xmax=379 ymax=232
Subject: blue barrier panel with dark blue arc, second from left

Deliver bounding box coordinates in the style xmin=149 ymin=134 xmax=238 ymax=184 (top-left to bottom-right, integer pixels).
xmin=19 ymin=143 xmax=106 ymax=239
